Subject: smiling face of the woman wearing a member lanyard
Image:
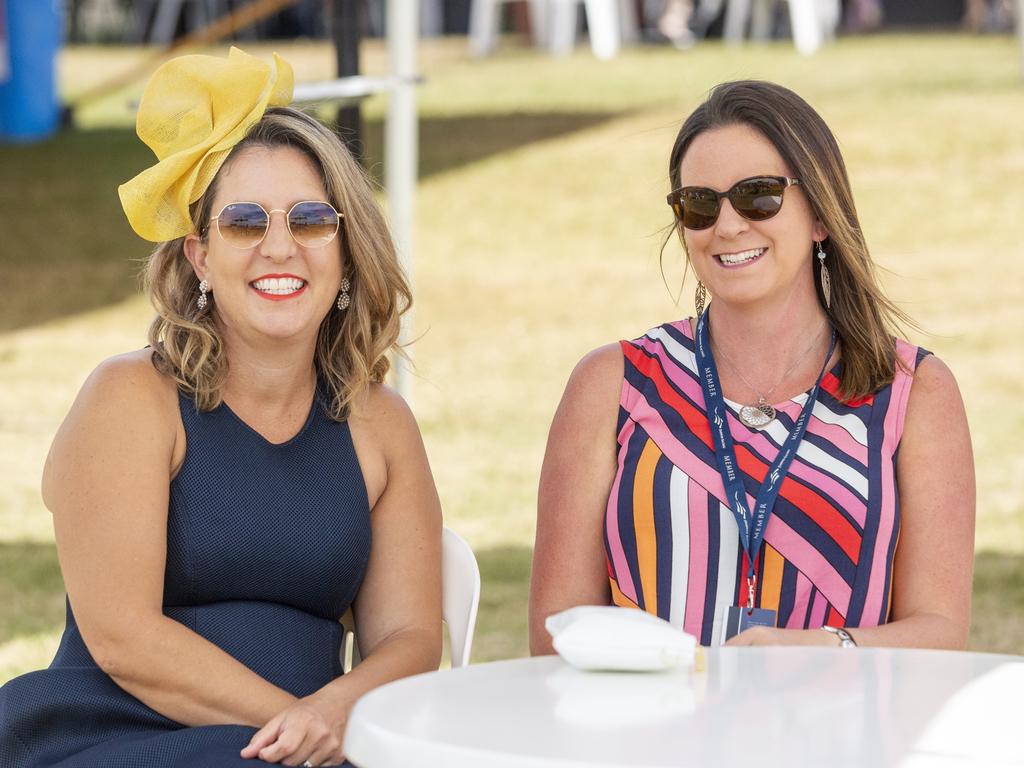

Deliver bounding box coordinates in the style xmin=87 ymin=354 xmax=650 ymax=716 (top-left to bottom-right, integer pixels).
xmin=680 ymin=124 xmax=826 ymax=307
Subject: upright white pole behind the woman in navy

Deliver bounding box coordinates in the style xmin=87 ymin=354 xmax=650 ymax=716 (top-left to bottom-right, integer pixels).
xmin=384 ymin=0 xmax=420 ymax=401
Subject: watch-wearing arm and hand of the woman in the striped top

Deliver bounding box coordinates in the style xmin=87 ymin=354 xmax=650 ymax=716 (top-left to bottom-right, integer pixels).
xmin=729 ymin=356 xmax=975 ymax=648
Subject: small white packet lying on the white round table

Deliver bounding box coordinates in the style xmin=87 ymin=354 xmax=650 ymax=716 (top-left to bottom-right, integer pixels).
xmin=544 ymin=605 xmax=697 ymax=672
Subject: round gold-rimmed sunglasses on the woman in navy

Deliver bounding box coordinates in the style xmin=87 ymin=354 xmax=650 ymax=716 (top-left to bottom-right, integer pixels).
xmin=204 ymin=200 xmax=342 ymax=249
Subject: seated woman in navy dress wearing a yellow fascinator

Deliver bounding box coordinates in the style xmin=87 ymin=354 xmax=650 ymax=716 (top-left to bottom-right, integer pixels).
xmin=0 ymin=49 xmax=440 ymax=768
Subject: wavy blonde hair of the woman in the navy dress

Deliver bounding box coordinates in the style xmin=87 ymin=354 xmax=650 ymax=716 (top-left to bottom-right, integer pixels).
xmin=143 ymin=108 xmax=413 ymax=421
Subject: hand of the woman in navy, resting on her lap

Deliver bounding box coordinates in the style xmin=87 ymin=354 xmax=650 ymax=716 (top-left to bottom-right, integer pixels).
xmin=241 ymin=693 xmax=348 ymax=766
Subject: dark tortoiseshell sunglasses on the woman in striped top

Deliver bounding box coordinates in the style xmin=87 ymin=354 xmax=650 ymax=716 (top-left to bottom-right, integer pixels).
xmin=668 ymin=176 xmax=800 ymax=229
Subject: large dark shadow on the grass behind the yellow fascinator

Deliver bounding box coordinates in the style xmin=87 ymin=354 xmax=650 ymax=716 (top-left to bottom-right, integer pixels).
xmin=0 ymin=113 xmax=612 ymax=332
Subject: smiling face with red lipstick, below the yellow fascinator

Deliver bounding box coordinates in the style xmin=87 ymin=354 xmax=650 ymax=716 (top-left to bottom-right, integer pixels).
xmin=184 ymin=146 xmax=343 ymax=344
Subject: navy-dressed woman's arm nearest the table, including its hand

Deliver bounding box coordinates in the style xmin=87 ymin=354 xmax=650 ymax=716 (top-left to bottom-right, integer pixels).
xmin=242 ymin=386 xmax=441 ymax=765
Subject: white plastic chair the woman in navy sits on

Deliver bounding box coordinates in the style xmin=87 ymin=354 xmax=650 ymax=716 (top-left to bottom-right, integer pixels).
xmin=341 ymin=526 xmax=480 ymax=673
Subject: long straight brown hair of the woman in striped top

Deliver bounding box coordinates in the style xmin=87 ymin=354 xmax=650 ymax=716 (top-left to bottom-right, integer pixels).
xmin=669 ymin=80 xmax=916 ymax=400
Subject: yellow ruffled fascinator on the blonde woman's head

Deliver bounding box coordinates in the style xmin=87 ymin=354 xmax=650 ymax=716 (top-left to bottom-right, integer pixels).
xmin=118 ymin=47 xmax=295 ymax=243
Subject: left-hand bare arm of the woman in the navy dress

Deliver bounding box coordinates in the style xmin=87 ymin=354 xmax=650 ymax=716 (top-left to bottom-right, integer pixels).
xmin=43 ymin=350 xmax=294 ymax=726
